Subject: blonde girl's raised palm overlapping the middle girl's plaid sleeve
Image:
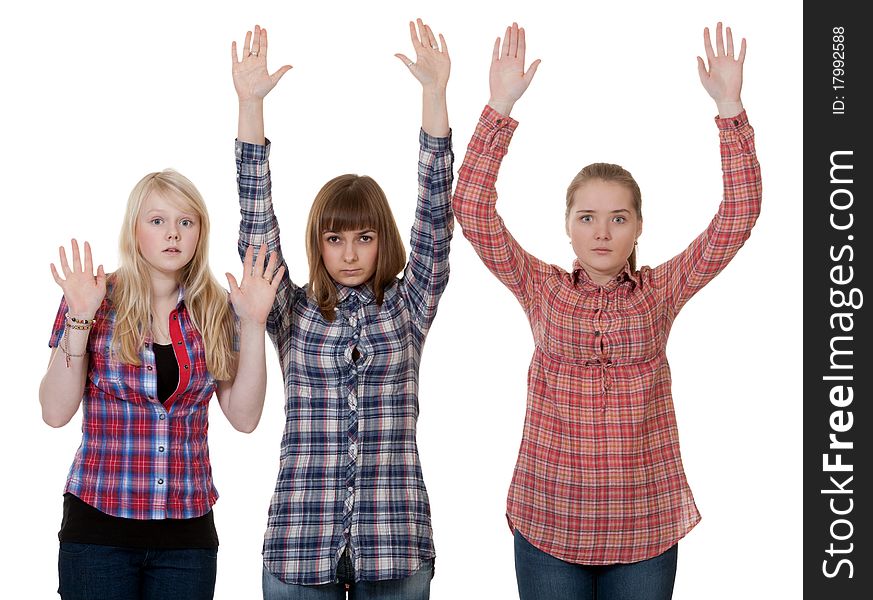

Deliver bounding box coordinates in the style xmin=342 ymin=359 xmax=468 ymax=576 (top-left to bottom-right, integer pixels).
xmin=225 ymin=244 xmax=285 ymax=324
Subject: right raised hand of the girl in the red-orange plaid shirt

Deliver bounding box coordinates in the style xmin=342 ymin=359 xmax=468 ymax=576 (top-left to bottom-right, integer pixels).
xmin=697 ymin=21 xmax=746 ymax=118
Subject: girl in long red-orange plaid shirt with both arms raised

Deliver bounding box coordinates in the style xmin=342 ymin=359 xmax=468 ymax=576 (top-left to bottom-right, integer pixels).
xmin=453 ymin=23 xmax=761 ymax=600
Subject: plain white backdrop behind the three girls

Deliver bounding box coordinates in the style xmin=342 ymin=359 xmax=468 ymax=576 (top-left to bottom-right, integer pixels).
xmin=0 ymin=0 xmax=802 ymax=600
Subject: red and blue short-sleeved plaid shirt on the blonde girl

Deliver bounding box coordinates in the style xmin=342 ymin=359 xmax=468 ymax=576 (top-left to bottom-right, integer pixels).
xmin=49 ymin=291 xmax=218 ymax=519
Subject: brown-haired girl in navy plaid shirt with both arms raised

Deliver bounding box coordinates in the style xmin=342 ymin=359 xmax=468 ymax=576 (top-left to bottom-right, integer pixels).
xmin=233 ymin=20 xmax=453 ymax=600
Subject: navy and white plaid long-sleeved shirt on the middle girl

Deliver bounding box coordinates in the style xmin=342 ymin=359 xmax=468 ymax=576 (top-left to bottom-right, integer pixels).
xmin=236 ymin=131 xmax=454 ymax=585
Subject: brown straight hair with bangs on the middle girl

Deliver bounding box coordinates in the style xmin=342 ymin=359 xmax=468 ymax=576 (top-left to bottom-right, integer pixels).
xmin=306 ymin=174 xmax=406 ymax=321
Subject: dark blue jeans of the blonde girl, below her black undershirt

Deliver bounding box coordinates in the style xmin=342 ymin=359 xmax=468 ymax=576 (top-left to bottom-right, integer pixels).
xmin=58 ymin=542 xmax=218 ymax=600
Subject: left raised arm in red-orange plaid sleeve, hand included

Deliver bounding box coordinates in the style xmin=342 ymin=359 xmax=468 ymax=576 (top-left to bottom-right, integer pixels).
xmin=452 ymin=23 xmax=549 ymax=312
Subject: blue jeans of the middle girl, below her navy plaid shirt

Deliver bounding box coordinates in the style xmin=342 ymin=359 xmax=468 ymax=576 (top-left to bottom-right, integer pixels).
xmin=263 ymin=559 xmax=433 ymax=600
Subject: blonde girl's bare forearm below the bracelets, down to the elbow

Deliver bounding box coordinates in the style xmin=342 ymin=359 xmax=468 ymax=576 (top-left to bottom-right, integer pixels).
xmin=39 ymin=330 xmax=89 ymax=427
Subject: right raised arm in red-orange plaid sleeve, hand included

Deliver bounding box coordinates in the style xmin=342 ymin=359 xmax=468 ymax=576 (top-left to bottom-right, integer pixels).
xmin=655 ymin=23 xmax=762 ymax=314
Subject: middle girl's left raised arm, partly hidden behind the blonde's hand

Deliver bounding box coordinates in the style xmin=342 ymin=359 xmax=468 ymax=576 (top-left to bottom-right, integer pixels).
xmin=231 ymin=25 xmax=296 ymax=345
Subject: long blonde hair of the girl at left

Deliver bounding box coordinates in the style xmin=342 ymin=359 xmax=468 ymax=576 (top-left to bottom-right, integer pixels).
xmin=109 ymin=169 xmax=235 ymax=380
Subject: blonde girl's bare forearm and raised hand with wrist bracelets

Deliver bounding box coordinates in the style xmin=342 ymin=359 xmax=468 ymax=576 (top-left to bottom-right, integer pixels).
xmin=39 ymin=240 xmax=106 ymax=427
